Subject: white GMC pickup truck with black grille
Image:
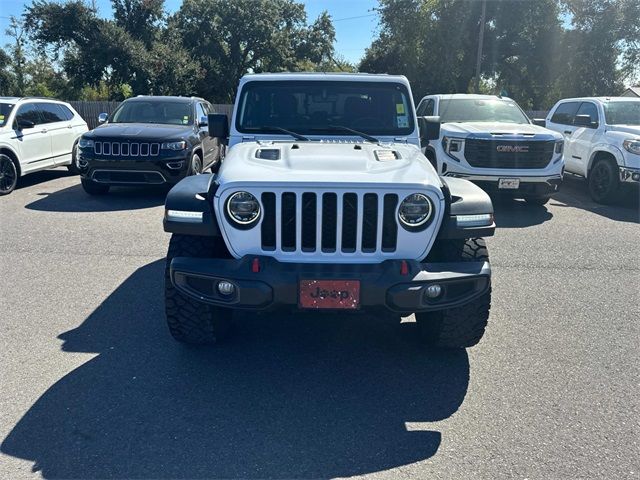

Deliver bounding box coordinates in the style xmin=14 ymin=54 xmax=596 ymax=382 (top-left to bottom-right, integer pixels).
xmin=417 ymin=94 xmax=564 ymax=205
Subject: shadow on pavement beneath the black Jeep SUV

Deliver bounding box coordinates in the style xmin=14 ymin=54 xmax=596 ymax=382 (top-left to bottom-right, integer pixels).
xmin=25 ymin=183 xmax=167 ymax=212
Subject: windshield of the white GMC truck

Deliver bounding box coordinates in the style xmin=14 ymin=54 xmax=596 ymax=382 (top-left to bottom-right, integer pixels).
xmin=438 ymin=98 xmax=529 ymax=123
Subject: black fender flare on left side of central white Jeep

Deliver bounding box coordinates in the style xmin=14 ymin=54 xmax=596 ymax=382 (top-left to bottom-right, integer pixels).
xmin=162 ymin=173 xmax=221 ymax=237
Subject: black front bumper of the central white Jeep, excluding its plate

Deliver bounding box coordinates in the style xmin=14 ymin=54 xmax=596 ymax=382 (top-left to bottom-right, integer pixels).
xmin=170 ymin=256 xmax=491 ymax=314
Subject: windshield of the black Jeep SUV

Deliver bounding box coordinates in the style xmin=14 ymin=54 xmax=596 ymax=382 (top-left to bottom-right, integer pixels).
xmin=109 ymin=100 xmax=193 ymax=125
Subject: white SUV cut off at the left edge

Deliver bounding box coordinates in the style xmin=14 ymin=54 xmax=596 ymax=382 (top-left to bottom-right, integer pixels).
xmin=0 ymin=97 xmax=88 ymax=195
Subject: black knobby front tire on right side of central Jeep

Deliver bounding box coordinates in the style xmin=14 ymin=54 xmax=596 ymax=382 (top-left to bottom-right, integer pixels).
xmin=415 ymin=238 xmax=491 ymax=348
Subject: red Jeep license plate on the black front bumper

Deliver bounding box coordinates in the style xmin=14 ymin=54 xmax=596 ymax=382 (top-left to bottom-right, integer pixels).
xmin=300 ymin=280 xmax=360 ymax=309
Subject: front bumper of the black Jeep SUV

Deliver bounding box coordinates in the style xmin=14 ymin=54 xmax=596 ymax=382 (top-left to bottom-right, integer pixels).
xmin=77 ymin=150 xmax=190 ymax=185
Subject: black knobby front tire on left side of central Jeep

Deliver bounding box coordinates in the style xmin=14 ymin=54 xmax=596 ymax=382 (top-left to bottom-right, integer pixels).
xmin=164 ymin=234 xmax=233 ymax=345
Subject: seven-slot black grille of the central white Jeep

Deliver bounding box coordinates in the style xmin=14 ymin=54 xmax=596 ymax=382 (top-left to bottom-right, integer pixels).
xmin=260 ymin=192 xmax=398 ymax=253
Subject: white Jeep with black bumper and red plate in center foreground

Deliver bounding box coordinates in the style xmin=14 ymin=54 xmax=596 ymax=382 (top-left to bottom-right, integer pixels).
xmin=164 ymin=73 xmax=495 ymax=348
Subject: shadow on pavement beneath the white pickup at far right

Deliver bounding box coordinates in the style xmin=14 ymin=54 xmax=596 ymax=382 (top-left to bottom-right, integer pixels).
xmin=550 ymin=175 xmax=640 ymax=223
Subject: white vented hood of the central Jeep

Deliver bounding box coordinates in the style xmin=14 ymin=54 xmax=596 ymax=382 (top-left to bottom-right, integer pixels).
xmin=218 ymin=142 xmax=440 ymax=186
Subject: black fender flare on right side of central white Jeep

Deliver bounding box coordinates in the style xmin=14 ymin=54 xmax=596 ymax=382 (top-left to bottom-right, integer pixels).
xmin=437 ymin=177 xmax=496 ymax=240
